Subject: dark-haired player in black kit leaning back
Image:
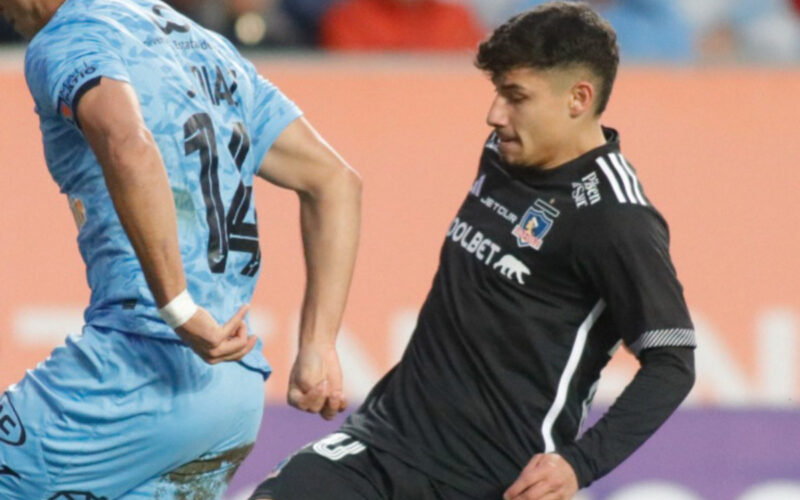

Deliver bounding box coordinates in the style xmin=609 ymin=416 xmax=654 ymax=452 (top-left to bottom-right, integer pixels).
xmin=253 ymin=2 xmax=695 ymax=500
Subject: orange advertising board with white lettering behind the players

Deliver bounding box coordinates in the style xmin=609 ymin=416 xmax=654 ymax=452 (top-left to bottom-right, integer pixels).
xmin=0 ymin=57 xmax=800 ymax=406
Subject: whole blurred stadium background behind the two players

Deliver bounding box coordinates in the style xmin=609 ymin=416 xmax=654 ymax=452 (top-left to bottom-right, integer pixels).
xmin=0 ymin=0 xmax=800 ymax=500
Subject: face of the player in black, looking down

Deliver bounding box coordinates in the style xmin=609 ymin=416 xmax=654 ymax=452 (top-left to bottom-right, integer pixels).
xmin=486 ymin=67 xmax=575 ymax=168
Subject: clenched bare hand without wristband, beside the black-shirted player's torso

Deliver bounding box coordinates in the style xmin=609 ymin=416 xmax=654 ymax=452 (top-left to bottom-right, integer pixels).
xmin=287 ymin=343 xmax=347 ymax=420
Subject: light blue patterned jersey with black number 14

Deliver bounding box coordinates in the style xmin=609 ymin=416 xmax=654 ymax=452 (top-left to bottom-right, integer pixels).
xmin=25 ymin=0 xmax=300 ymax=369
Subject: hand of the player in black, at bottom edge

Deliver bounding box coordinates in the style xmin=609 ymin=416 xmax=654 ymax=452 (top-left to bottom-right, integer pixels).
xmin=503 ymin=453 xmax=578 ymax=500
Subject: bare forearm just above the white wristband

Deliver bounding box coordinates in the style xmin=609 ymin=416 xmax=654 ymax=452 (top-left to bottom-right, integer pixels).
xmin=95 ymin=129 xmax=186 ymax=306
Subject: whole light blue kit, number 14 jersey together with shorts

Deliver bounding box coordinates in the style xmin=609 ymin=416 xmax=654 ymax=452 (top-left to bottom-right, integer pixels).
xmin=0 ymin=0 xmax=300 ymax=500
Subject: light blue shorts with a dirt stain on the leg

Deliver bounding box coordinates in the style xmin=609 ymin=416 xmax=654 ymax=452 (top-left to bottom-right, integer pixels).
xmin=0 ymin=327 xmax=265 ymax=500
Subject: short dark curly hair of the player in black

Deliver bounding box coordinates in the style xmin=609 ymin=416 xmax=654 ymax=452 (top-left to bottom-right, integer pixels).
xmin=475 ymin=2 xmax=619 ymax=115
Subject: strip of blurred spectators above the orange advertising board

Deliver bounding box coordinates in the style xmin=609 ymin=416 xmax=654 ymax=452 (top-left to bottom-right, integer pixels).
xmin=0 ymin=0 xmax=800 ymax=63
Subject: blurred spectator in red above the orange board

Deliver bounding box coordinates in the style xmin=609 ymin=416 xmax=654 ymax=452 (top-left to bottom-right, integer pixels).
xmin=321 ymin=0 xmax=484 ymax=50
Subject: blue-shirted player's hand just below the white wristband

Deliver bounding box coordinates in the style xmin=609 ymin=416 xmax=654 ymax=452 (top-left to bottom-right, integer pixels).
xmin=175 ymin=305 xmax=257 ymax=365
